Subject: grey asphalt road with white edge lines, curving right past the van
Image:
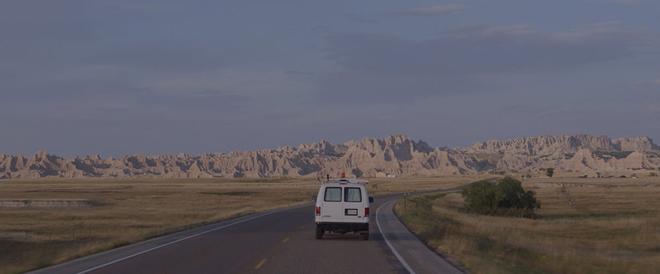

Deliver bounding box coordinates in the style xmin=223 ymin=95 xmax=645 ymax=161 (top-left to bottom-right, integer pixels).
xmin=34 ymin=196 xmax=461 ymax=273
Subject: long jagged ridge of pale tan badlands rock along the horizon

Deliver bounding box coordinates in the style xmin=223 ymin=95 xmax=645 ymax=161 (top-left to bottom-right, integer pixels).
xmin=0 ymin=135 xmax=660 ymax=179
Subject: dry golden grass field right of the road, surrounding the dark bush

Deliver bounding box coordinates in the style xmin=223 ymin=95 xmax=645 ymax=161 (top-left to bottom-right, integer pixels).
xmin=396 ymin=178 xmax=660 ymax=273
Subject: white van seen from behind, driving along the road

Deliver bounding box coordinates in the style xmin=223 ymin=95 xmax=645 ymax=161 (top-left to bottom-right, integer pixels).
xmin=314 ymin=179 xmax=373 ymax=240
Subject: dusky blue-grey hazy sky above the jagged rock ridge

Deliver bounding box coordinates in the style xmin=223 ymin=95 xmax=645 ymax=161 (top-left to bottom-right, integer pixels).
xmin=0 ymin=0 xmax=660 ymax=155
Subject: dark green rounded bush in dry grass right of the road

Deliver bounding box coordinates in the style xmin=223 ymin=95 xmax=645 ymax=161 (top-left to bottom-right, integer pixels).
xmin=463 ymin=177 xmax=541 ymax=217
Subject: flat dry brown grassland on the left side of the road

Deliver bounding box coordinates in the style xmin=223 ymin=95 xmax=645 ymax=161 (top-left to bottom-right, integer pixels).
xmin=0 ymin=177 xmax=471 ymax=273
